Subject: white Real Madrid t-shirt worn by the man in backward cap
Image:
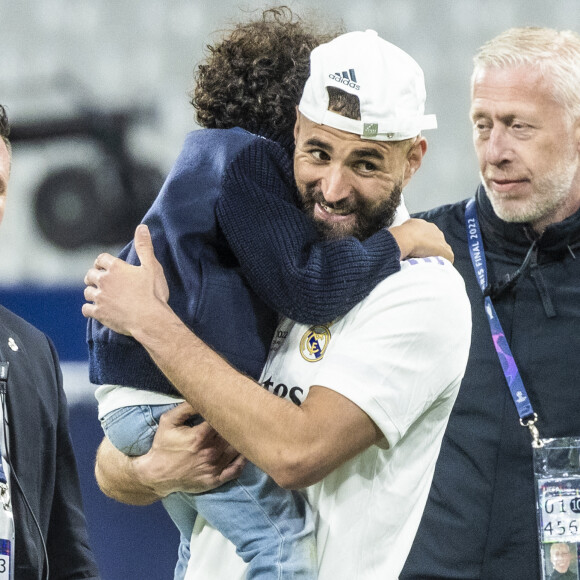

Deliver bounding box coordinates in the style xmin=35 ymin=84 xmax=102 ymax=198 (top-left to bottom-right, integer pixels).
xmin=186 ymin=258 xmax=471 ymax=580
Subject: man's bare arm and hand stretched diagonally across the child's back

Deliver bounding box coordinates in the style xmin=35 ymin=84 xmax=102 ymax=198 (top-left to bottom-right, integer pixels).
xmin=83 ymin=226 xmax=382 ymax=488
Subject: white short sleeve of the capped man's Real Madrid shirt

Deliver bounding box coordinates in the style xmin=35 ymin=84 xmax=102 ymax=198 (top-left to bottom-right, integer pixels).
xmin=313 ymin=258 xmax=471 ymax=447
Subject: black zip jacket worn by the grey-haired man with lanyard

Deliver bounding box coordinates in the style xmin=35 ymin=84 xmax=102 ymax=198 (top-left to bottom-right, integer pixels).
xmin=400 ymin=188 xmax=580 ymax=580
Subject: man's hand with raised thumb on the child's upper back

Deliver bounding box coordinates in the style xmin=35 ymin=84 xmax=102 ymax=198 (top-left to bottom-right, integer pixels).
xmin=82 ymin=225 xmax=169 ymax=335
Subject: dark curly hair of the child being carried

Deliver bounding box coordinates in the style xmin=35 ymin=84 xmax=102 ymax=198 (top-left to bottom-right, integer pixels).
xmin=190 ymin=6 xmax=342 ymax=134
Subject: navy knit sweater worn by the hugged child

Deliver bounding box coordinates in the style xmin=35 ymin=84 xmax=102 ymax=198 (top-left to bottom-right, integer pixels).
xmin=87 ymin=128 xmax=400 ymax=395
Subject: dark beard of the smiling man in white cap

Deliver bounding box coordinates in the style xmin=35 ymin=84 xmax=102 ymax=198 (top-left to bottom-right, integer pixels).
xmin=302 ymin=182 xmax=403 ymax=240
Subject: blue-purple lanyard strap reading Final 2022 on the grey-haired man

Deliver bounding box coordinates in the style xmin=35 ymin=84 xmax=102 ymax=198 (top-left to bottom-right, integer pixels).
xmin=465 ymin=198 xmax=539 ymax=446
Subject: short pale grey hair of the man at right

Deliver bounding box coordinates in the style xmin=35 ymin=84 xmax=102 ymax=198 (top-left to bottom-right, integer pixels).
xmin=471 ymin=26 xmax=580 ymax=121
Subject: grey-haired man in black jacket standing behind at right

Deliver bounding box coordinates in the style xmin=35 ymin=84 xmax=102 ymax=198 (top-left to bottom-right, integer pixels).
xmin=400 ymin=28 xmax=580 ymax=580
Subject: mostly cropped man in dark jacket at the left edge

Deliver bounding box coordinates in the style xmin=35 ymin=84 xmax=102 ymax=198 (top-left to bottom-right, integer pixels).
xmin=0 ymin=105 xmax=99 ymax=580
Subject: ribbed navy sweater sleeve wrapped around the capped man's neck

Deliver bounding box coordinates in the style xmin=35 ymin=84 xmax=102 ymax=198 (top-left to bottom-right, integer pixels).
xmin=216 ymin=139 xmax=400 ymax=324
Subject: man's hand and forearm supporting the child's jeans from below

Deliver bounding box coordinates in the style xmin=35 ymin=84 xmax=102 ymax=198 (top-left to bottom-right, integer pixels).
xmin=95 ymin=403 xmax=246 ymax=505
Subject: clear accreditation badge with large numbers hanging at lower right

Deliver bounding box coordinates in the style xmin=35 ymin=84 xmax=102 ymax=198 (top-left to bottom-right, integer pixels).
xmin=533 ymin=437 xmax=580 ymax=580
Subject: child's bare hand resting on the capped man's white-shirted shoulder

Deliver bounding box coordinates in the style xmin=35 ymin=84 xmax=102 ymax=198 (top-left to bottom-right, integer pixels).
xmin=389 ymin=218 xmax=454 ymax=263
